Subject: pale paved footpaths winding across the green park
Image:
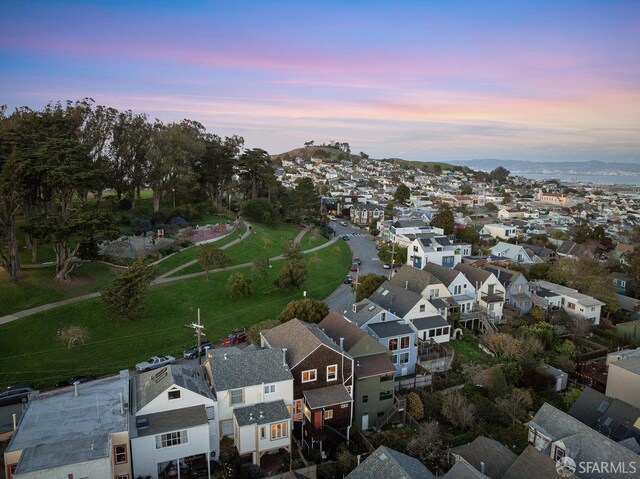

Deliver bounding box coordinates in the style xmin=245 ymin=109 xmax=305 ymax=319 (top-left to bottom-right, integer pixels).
xmin=0 ymin=226 xmax=324 ymax=324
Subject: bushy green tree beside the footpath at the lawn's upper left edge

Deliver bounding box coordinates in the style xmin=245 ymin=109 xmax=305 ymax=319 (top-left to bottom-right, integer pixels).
xmin=102 ymin=259 xmax=154 ymax=321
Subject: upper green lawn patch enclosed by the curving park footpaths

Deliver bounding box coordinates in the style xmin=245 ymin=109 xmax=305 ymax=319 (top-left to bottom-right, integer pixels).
xmin=169 ymin=224 xmax=300 ymax=276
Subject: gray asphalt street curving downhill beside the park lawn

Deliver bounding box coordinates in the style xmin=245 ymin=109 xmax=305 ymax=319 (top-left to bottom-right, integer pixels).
xmin=324 ymin=221 xmax=389 ymax=313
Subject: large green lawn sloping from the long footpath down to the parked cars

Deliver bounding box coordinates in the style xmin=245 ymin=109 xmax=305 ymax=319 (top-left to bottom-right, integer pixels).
xmin=0 ymin=243 xmax=351 ymax=388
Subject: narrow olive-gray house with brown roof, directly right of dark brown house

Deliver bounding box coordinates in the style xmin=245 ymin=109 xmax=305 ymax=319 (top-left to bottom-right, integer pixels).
xmin=318 ymin=311 xmax=396 ymax=431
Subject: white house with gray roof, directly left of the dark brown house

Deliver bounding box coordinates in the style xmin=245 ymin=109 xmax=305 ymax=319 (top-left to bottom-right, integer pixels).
xmin=204 ymin=348 xmax=293 ymax=464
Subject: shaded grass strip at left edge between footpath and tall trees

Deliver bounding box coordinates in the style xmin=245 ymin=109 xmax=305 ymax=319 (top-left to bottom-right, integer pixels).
xmin=0 ymin=263 xmax=115 ymax=316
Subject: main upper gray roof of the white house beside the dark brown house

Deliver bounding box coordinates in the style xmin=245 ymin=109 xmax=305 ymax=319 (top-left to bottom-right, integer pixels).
xmin=209 ymin=348 xmax=293 ymax=391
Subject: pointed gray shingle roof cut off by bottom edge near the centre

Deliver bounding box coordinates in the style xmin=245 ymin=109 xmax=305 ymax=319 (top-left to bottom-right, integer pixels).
xmin=346 ymin=446 xmax=436 ymax=479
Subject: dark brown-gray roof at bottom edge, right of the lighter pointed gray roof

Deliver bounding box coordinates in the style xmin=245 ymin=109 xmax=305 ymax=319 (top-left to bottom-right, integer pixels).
xmin=451 ymin=436 xmax=518 ymax=477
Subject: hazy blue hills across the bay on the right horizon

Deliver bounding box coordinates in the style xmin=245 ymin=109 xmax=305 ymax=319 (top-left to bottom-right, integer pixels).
xmin=444 ymin=159 xmax=640 ymax=175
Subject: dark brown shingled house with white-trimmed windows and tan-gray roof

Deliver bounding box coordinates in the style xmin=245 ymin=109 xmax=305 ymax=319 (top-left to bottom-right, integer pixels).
xmin=260 ymin=319 xmax=354 ymax=450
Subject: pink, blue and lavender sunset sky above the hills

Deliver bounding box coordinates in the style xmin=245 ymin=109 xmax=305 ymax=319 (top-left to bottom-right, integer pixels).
xmin=0 ymin=0 xmax=640 ymax=163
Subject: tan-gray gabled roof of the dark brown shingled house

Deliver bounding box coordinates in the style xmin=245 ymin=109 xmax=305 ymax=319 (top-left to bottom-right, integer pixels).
xmin=262 ymin=318 xmax=341 ymax=368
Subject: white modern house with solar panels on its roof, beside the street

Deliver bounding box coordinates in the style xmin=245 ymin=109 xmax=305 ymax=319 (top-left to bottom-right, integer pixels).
xmin=407 ymin=234 xmax=471 ymax=269
